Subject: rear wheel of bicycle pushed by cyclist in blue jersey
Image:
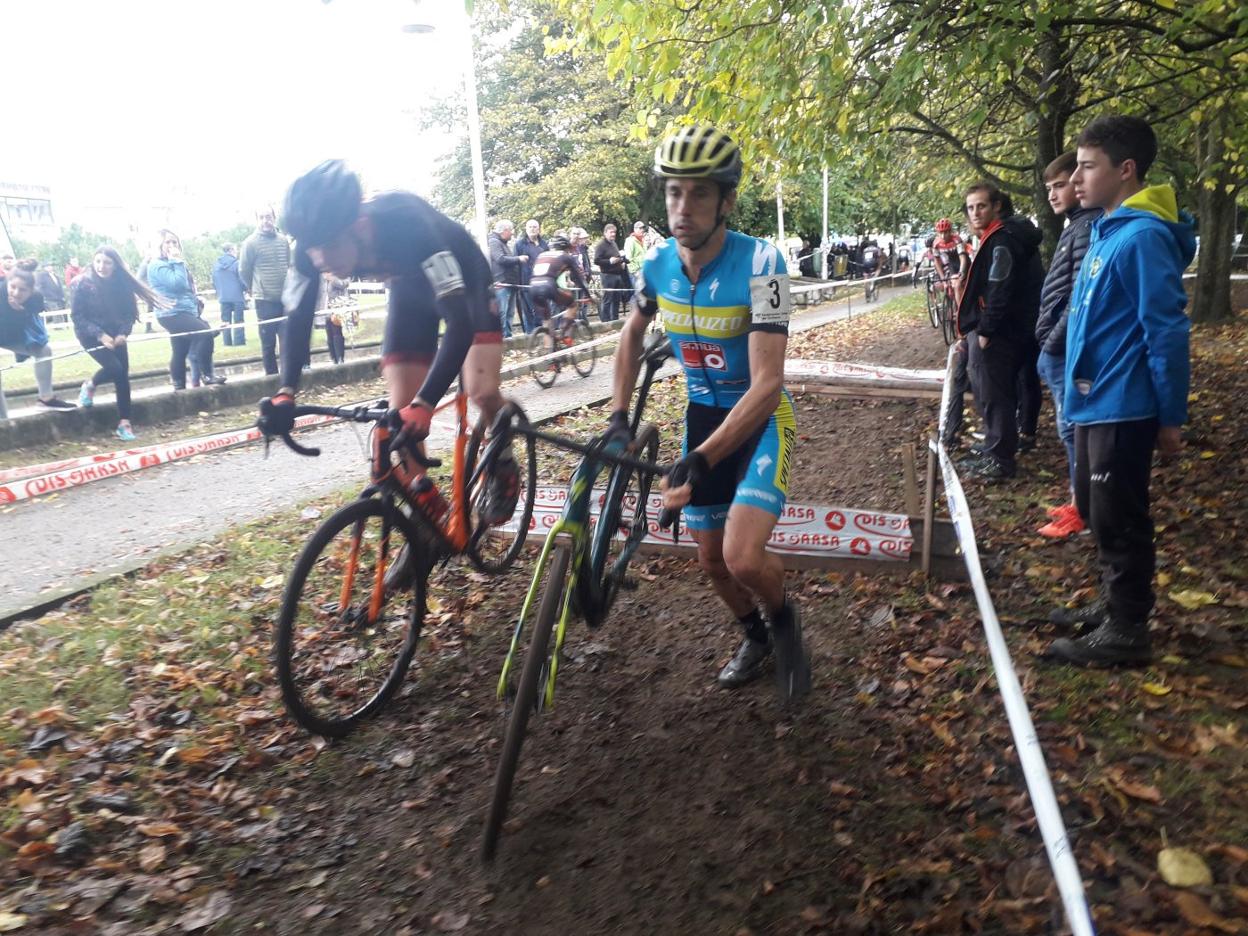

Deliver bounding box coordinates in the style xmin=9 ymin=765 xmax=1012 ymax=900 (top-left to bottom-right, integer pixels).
xmin=577 ymin=423 xmax=659 ymax=626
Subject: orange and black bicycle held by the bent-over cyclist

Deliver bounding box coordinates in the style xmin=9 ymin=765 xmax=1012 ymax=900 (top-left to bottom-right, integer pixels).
xmin=261 ymin=392 xmax=537 ymax=738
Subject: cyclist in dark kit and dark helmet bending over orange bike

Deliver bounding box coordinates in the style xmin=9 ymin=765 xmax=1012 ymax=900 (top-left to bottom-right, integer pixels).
xmin=258 ymin=160 xmax=519 ymax=523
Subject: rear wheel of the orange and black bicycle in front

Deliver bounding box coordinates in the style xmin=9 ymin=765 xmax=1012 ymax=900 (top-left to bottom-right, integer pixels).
xmin=464 ymin=414 xmax=538 ymax=574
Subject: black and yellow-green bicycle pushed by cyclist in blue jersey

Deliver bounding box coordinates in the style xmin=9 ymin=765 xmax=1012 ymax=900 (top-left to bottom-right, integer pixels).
xmin=480 ymin=333 xmax=671 ymax=861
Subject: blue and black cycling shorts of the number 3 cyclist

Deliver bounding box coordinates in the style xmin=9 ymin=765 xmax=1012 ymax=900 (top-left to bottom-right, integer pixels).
xmin=684 ymin=392 xmax=797 ymax=529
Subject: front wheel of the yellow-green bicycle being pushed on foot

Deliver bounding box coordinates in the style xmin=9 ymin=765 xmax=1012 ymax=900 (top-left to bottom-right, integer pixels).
xmin=480 ymin=545 xmax=572 ymax=861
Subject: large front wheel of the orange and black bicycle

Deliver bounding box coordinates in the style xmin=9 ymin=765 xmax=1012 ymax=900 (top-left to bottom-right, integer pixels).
xmin=273 ymin=498 xmax=433 ymax=738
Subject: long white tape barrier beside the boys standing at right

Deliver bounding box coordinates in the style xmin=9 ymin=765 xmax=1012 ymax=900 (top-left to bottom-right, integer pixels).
xmin=929 ymin=348 xmax=1096 ymax=936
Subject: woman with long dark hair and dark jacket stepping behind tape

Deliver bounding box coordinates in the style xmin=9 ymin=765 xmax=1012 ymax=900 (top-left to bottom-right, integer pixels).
xmin=70 ymin=246 xmax=166 ymax=442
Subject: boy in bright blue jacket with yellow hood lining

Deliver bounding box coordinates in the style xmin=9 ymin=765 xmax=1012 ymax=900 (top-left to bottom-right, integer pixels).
xmin=1048 ymin=116 xmax=1196 ymax=666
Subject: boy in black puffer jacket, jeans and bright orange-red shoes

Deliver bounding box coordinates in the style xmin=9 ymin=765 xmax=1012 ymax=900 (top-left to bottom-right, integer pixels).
xmin=1036 ymin=150 xmax=1102 ymax=539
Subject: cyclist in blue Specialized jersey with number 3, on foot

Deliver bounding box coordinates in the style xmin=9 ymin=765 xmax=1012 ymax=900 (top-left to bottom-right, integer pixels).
xmin=607 ymin=126 xmax=810 ymax=700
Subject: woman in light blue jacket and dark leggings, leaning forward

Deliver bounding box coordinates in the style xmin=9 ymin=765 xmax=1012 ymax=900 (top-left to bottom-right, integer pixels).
xmin=147 ymin=231 xmax=225 ymax=389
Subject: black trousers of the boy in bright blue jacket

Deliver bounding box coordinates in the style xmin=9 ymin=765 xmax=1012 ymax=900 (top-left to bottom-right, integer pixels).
xmin=1075 ymin=419 xmax=1157 ymax=626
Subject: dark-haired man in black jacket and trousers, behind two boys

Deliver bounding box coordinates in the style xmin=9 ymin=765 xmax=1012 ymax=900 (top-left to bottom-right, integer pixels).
xmin=957 ymin=182 xmax=1045 ymax=480
